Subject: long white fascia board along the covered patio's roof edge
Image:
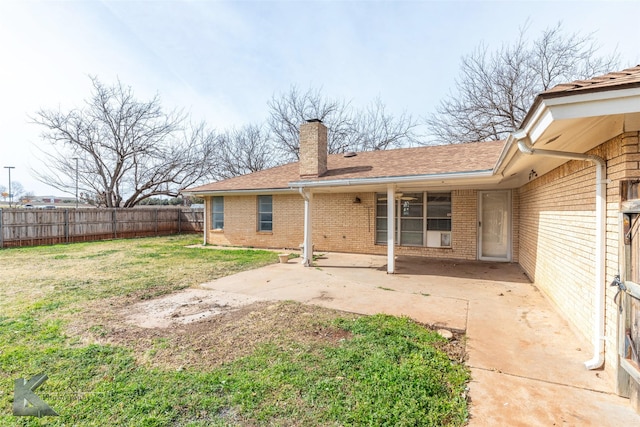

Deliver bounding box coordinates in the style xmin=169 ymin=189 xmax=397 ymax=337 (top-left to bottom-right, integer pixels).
xmin=289 ymin=169 xmax=493 ymax=188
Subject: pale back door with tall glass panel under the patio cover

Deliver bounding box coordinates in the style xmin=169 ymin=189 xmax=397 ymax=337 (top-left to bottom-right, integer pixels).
xmin=478 ymin=191 xmax=511 ymax=261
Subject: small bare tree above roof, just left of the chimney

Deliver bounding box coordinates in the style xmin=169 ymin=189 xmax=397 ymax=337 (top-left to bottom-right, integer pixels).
xmin=216 ymin=125 xmax=277 ymax=179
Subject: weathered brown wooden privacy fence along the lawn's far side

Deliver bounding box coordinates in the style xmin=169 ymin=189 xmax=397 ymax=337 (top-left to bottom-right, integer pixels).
xmin=0 ymin=208 xmax=204 ymax=248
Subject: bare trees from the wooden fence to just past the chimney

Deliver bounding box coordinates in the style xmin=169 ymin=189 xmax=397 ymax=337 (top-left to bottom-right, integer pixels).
xmin=32 ymin=77 xmax=418 ymax=208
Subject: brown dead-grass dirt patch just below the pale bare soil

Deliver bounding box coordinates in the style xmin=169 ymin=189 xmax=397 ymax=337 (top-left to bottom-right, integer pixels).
xmin=68 ymin=298 xmax=358 ymax=370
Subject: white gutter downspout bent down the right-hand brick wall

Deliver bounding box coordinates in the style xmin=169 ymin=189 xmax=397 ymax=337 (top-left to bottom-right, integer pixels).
xmin=513 ymin=131 xmax=607 ymax=369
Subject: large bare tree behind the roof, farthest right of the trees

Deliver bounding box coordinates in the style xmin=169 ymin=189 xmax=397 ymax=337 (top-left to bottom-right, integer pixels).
xmin=427 ymin=23 xmax=618 ymax=144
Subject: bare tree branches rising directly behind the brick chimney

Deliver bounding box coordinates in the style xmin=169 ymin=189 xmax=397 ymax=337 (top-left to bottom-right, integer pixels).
xmin=268 ymin=86 xmax=417 ymax=161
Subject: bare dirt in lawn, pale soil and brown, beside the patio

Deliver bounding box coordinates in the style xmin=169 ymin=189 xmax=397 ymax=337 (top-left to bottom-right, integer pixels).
xmin=68 ymin=289 xmax=466 ymax=370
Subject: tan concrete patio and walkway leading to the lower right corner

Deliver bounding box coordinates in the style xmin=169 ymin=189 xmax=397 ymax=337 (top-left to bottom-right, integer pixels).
xmin=202 ymin=254 xmax=640 ymax=426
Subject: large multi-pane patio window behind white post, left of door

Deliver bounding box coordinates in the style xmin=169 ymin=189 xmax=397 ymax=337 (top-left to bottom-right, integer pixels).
xmin=376 ymin=192 xmax=451 ymax=247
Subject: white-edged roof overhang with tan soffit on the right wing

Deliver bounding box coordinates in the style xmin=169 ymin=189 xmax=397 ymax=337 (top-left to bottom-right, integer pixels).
xmin=494 ymin=87 xmax=640 ymax=187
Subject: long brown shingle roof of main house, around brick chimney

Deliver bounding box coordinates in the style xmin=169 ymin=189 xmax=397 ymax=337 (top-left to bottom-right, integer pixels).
xmin=187 ymin=141 xmax=505 ymax=193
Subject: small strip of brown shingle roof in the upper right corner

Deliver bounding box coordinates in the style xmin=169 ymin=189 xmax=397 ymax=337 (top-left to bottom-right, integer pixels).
xmin=540 ymin=65 xmax=640 ymax=98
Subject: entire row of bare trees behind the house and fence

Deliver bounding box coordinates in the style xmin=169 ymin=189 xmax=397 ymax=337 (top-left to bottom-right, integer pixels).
xmin=32 ymin=24 xmax=618 ymax=207
